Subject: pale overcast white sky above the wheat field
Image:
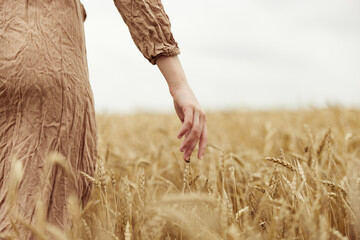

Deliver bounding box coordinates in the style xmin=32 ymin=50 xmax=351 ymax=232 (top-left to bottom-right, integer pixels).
xmin=81 ymin=0 xmax=360 ymax=113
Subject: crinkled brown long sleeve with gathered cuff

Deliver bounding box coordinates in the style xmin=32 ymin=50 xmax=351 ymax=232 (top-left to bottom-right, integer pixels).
xmin=114 ymin=0 xmax=180 ymax=65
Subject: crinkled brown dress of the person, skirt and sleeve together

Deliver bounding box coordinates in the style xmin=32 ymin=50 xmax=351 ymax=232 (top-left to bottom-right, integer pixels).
xmin=0 ymin=0 xmax=180 ymax=239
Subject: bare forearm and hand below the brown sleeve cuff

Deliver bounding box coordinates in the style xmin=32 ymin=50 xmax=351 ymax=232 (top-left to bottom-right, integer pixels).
xmin=156 ymin=56 xmax=207 ymax=160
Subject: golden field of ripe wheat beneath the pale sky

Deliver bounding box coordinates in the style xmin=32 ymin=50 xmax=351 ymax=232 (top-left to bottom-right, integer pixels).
xmin=0 ymin=107 xmax=360 ymax=240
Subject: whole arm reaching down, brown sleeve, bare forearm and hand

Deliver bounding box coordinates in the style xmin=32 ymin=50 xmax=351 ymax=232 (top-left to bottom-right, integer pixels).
xmin=114 ymin=0 xmax=207 ymax=160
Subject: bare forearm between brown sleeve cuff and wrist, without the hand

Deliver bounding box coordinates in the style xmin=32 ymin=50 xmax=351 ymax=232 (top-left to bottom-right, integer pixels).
xmin=156 ymin=55 xmax=189 ymax=96
